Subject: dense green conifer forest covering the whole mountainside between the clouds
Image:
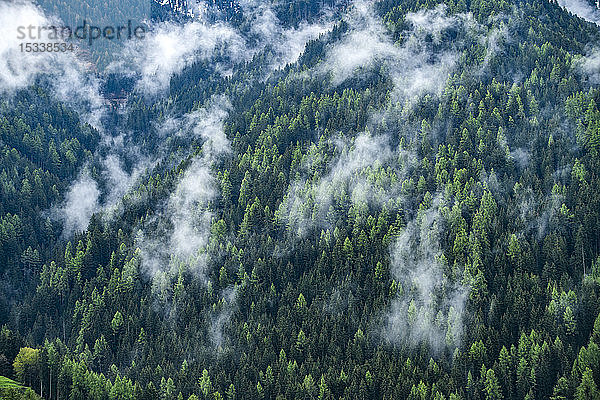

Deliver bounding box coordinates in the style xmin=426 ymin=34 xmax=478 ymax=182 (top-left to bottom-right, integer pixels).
xmin=0 ymin=0 xmax=600 ymax=400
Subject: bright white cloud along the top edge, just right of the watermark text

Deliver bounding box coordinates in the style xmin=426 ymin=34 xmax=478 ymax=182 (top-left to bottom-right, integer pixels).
xmin=108 ymin=2 xmax=333 ymax=96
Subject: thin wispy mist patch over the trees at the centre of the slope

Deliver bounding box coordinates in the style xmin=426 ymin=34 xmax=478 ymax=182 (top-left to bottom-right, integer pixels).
xmin=276 ymin=133 xmax=413 ymax=236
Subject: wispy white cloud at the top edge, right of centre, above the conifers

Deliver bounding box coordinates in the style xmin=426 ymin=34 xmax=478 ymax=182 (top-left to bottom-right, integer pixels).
xmin=320 ymin=1 xmax=474 ymax=100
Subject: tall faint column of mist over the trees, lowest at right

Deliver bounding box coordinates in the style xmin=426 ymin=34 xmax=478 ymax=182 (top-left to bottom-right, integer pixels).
xmin=383 ymin=197 xmax=469 ymax=352
